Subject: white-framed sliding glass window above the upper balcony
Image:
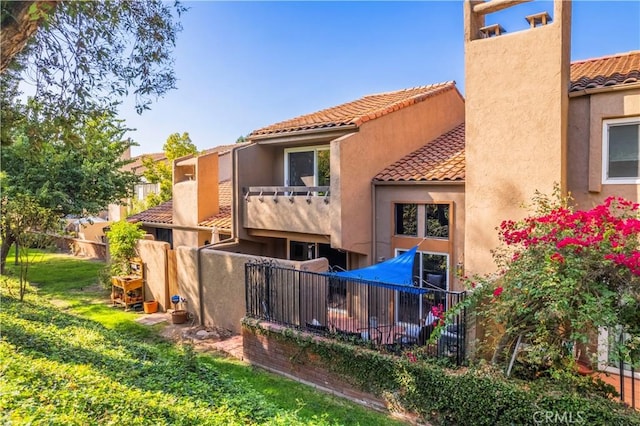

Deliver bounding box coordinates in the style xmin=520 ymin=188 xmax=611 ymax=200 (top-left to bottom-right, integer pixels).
xmin=284 ymin=146 xmax=331 ymax=186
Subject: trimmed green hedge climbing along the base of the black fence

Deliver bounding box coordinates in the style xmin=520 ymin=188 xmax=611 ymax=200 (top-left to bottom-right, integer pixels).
xmin=243 ymin=319 xmax=640 ymax=426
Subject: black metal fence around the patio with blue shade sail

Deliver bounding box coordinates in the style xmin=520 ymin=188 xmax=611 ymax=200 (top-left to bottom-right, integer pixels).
xmin=245 ymin=262 xmax=466 ymax=365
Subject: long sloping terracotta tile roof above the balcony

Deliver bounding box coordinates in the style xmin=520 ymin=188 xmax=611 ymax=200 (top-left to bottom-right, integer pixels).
xmin=249 ymin=81 xmax=455 ymax=138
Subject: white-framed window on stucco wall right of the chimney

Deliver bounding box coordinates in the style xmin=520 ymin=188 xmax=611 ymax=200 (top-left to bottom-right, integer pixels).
xmin=602 ymin=117 xmax=640 ymax=184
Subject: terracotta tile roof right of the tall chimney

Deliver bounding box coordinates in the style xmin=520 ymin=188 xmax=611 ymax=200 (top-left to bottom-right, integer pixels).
xmin=569 ymin=50 xmax=640 ymax=92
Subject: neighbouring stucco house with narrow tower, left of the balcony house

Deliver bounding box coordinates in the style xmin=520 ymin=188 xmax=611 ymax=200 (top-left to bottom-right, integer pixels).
xmin=127 ymin=144 xmax=242 ymax=247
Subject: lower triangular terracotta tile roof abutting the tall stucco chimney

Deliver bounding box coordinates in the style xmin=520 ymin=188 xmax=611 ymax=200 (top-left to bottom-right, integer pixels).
xmin=373 ymin=123 xmax=465 ymax=182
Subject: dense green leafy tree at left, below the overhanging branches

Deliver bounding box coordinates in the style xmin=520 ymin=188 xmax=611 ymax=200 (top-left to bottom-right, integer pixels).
xmin=0 ymin=108 xmax=137 ymax=271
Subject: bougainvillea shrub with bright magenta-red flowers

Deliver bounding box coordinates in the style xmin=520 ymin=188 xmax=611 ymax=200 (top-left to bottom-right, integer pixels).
xmin=456 ymin=190 xmax=640 ymax=371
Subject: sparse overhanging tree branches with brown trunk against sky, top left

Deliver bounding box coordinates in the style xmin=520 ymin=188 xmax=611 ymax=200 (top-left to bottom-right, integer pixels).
xmin=0 ymin=0 xmax=186 ymax=117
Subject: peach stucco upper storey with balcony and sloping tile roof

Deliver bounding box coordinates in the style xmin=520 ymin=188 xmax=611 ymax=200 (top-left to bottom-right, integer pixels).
xmin=234 ymin=82 xmax=464 ymax=269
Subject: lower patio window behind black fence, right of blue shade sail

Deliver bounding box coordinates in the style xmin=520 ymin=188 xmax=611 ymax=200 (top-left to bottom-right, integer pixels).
xmin=395 ymin=250 xmax=449 ymax=324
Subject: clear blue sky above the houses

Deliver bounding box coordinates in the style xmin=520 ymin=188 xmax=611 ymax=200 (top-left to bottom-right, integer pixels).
xmin=121 ymin=0 xmax=640 ymax=155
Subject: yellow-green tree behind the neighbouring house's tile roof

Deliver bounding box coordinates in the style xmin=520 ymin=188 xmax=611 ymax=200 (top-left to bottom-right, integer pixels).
xmin=142 ymin=132 xmax=198 ymax=208
